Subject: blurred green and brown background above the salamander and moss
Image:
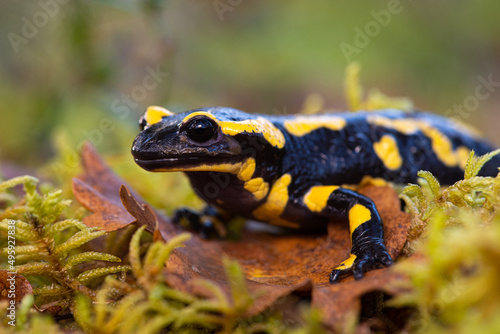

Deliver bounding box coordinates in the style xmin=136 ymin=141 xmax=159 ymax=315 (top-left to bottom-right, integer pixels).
xmin=0 ymin=0 xmax=500 ymax=193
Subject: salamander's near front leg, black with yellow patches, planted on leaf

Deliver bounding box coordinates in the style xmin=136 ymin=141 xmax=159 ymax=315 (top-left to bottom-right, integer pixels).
xmin=304 ymin=186 xmax=393 ymax=283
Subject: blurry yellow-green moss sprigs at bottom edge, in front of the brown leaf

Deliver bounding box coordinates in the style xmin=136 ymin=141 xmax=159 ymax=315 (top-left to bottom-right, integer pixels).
xmin=73 ymin=227 xmax=300 ymax=333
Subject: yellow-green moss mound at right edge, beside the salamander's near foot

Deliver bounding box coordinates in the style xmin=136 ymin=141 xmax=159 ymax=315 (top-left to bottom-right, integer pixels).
xmin=393 ymin=150 xmax=500 ymax=333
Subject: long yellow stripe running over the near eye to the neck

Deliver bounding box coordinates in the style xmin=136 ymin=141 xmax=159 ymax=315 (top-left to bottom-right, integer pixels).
xmin=182 ymin=111 xmax=285 ymax=148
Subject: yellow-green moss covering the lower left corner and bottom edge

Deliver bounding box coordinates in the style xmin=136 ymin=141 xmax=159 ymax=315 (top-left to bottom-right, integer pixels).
xmin=0 ymin=176 xmax=319 ymax=333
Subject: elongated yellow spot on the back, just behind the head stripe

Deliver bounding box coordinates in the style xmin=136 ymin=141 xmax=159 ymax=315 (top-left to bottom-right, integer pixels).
xmin=284 ymin=115 xmax=346 ymax=137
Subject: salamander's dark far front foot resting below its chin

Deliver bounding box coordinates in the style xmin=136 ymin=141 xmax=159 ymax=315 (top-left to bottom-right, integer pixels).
xmin=172 ymin=205 xmax=229 ymax=239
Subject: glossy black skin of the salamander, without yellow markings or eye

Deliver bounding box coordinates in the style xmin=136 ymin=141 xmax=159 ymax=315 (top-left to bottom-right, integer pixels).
xmin=132 ymin=107 xmax=500 ymax=281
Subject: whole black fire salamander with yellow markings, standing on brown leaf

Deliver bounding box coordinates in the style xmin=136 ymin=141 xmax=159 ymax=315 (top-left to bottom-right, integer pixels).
xmin=132 ymin=106 xmax=500 ymax=282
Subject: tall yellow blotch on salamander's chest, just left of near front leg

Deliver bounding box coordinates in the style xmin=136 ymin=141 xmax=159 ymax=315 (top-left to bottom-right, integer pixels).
xmin=252 ymin=174 xmax=292 ymax=225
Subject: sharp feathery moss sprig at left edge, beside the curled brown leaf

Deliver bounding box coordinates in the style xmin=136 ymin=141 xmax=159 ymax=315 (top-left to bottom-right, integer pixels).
xmin=0 ymin=176 xmax=130 ymax=306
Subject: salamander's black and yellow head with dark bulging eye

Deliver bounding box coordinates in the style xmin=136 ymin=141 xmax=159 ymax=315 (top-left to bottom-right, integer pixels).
xmin=132 ymin=107 xmax=285 ymax=173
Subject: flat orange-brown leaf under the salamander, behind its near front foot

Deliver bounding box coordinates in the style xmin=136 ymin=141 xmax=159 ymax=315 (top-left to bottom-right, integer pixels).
xmin=218 ymin=186 xmax=410 ymax=286
